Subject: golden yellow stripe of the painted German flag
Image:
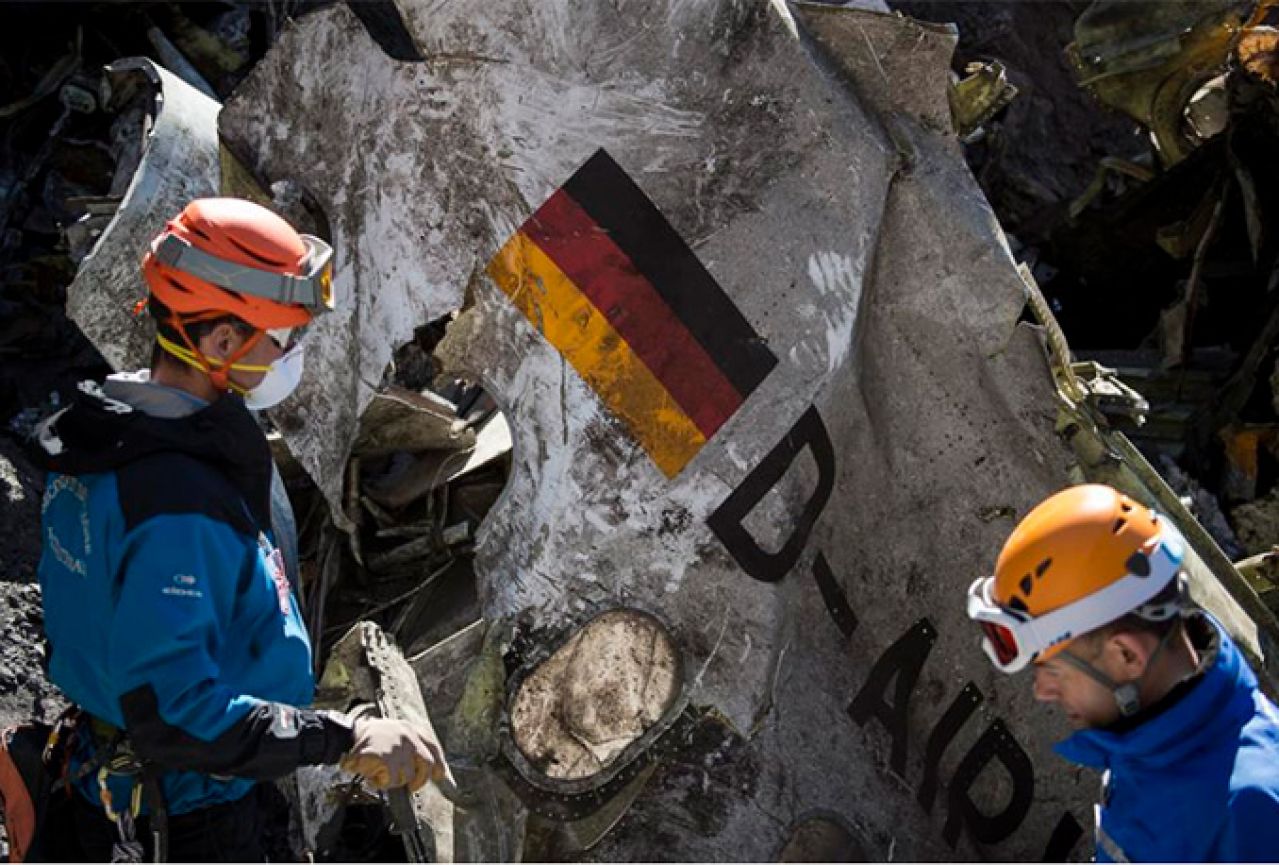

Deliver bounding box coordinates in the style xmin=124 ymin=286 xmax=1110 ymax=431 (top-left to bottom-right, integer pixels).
xmin=487 ymin=233 xmax=706 ymax=477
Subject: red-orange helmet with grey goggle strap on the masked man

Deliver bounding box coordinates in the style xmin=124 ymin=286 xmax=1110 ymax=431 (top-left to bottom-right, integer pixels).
xmin=142 ymin=198 xmax=333 ymax=330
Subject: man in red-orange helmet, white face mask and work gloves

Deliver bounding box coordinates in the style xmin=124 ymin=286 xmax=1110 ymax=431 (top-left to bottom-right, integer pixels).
xmin=40 ymin=198 xmax=444 ymax=861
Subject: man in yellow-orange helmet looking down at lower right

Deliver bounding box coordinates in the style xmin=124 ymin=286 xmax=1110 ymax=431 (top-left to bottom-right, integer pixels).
xmin=968 ymin=485 xmax=1279 ymax=862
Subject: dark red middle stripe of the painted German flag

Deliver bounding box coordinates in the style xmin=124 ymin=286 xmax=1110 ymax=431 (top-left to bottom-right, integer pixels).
xmin=521 ymin=189 xmax=742 ymax=439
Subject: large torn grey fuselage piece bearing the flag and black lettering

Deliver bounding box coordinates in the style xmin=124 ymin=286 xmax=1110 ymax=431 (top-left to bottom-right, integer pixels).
xmin=62 ymin=0 xmax=1275 ymax=861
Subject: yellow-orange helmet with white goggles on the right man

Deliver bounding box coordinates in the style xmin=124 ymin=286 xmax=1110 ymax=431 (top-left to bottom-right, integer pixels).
xmin=968 ymin=484 xmax=1186 ymax=672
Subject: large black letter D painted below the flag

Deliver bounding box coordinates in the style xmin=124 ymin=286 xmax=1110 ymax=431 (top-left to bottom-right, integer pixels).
xmin=707 ymin=406 xmax=835 ymax=582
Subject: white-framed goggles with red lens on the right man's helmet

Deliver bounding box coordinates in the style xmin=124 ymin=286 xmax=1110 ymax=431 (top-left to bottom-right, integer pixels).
xmin=968 ymin=517 xmax=1186 ymax=673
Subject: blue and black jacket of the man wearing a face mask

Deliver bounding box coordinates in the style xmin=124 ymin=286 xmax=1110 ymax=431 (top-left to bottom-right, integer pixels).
xmin=40 ymin=377 xmax=352 ymax=814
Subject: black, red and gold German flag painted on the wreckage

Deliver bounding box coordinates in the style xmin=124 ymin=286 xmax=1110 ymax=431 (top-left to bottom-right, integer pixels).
xmin=489 ymin=150 xmax=778 ymax=477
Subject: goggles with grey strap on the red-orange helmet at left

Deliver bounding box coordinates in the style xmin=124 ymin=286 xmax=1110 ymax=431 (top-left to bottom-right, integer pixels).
xmin=151 ymin=232 xmax=333 ymax=315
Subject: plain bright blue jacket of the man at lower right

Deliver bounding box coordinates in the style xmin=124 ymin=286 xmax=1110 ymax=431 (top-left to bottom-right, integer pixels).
xmin=1056 ymin=614 xmax=1279 ymax=862
